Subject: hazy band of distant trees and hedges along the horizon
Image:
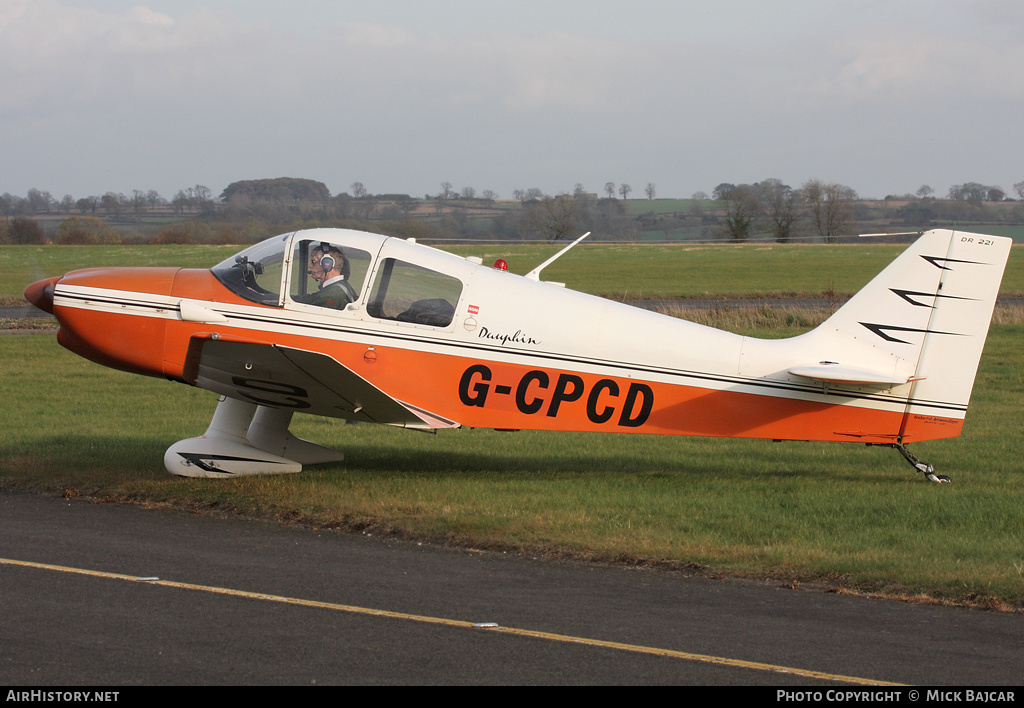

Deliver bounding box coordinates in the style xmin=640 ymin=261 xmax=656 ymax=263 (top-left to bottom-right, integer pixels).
xmin=6 ymin=178 xmax=1024 ymax=243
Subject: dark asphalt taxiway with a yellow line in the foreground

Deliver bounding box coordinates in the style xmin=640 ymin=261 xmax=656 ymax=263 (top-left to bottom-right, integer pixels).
xmin=0 ymin=492 xmax=1024 ymax=686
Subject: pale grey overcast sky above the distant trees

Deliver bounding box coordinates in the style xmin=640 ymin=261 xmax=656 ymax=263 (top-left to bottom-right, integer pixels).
xmin=0 ymin=0 xmax=1024 ymax=199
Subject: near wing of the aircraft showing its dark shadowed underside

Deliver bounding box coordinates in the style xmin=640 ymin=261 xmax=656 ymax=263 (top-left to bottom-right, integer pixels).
xmin=184 ymin=335 xmax=459 ymax=428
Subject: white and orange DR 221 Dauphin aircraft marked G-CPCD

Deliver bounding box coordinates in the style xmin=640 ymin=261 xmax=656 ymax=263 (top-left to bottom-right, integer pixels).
xmin=25 ymin=228 xmax=1011 ymax=481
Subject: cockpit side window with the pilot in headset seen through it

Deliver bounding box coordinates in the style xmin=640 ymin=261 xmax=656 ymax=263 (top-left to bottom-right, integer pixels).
xmin=290 ymin=240 xmax=371 ymax=309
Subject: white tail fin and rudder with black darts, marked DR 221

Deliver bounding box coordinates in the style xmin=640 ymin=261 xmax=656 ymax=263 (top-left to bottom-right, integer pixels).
xmin=806 ymin=230 xmax=1013 ymax=442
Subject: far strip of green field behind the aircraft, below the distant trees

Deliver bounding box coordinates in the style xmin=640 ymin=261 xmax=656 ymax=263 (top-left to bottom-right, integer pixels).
xmin=0 ymin=242 xmax=1024 ymax=300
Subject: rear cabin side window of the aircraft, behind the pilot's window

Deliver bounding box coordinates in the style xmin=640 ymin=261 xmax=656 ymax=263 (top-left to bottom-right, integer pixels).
xmin=367 ymin=258 xmax=462 ymax=327
